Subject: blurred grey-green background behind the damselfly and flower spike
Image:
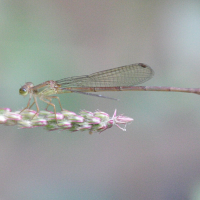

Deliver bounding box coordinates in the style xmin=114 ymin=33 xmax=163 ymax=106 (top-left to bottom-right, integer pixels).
xmin=0 ymin=0 xmax=200 ymax=200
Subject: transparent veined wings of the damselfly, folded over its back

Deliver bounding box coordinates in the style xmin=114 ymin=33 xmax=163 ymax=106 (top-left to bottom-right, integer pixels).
xmin=56 ymin=63 xmax=154 ymax=88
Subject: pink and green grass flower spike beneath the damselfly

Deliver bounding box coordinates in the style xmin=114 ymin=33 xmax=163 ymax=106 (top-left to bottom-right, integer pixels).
xmin=0 ymin=108 xmax=133 ymax=133
